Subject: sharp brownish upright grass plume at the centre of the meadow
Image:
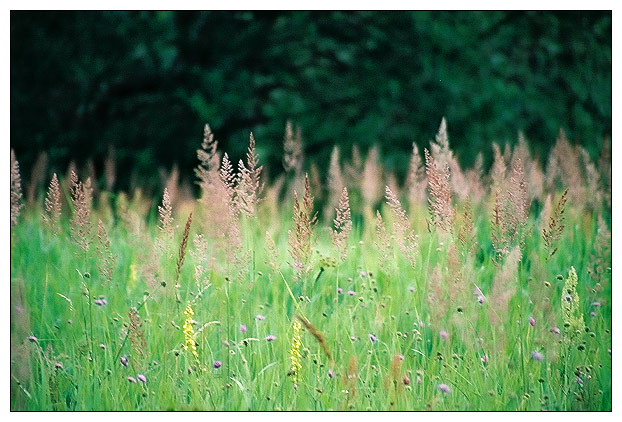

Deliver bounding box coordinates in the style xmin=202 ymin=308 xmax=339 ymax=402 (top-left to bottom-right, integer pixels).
xmin=288 ymin=174 xmax=317 ymax=279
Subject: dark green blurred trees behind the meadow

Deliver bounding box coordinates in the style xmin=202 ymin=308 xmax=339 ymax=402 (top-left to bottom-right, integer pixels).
xmin=10 ymin=11 xmax=611 ymax=192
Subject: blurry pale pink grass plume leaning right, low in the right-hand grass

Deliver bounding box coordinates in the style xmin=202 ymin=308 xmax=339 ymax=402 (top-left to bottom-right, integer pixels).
xmin=489 ymin=246 xmax=522 ymax=325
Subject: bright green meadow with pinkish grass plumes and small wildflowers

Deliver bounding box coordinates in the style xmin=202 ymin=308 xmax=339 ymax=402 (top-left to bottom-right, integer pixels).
xmin=10 ymin=120 xmax=612 ymax=411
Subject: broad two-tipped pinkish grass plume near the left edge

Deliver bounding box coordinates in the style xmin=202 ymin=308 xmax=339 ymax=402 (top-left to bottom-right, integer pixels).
xmin=70 ymin=172 xmax=93 ymax=253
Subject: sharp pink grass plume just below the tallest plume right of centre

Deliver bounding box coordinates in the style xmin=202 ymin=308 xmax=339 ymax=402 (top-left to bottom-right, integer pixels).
xmin=424 ymin=149 xmax=454 ymax=233
